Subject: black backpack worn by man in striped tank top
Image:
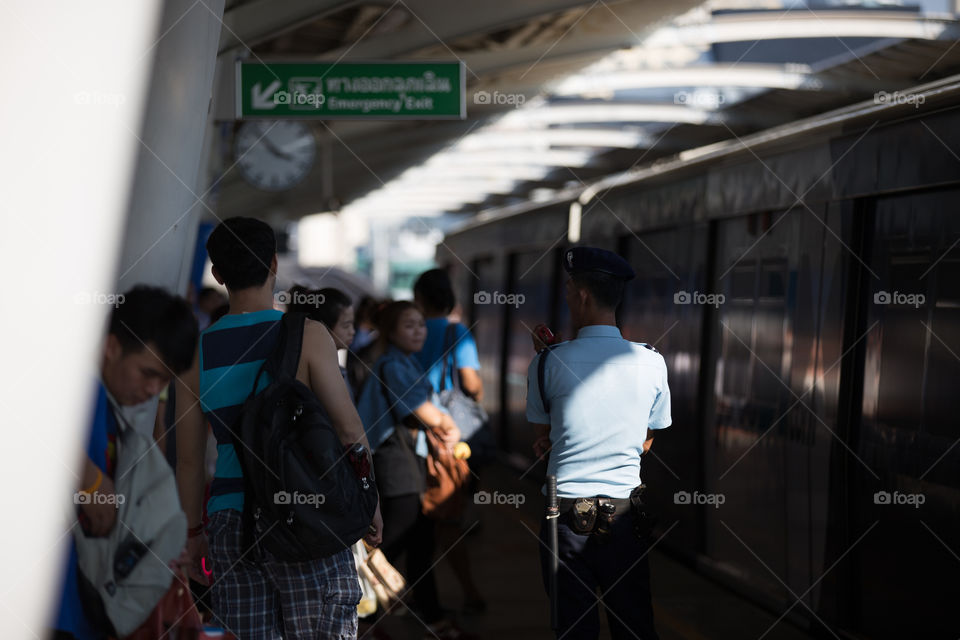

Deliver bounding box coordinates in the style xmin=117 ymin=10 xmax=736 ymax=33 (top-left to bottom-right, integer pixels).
xmin=234 ymin=313 xmax=378 ymax=562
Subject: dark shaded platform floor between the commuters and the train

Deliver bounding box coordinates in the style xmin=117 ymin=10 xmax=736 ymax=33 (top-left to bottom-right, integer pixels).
xmin=358 ymin=465 xmax=813 ymax=640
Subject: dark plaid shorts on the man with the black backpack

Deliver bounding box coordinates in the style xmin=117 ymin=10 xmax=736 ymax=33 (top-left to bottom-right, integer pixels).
xmin=207 ymin=509 xmax=360 ymax=640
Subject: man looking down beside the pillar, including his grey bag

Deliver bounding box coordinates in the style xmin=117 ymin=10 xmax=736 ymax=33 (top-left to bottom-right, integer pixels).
xmin=54 ymin=286 xmax=197 ymax=640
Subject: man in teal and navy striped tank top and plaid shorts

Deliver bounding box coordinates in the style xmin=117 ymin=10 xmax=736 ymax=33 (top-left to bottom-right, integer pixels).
xmin=176 ymin=217 xmax=383 ymax=640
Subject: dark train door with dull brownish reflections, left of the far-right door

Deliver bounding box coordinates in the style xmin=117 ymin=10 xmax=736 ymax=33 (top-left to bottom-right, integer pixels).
xmin=702 ymin=208 xmax=841 ymax=604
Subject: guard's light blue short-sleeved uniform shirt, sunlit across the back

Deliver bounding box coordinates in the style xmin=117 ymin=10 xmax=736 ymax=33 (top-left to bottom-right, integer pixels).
xmin=527 ymin=325 xmax=671 ymax=498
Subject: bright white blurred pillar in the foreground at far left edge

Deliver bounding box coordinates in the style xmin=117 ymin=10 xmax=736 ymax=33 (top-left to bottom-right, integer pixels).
xmin=0 ymin=0 xmax=161 ymax=638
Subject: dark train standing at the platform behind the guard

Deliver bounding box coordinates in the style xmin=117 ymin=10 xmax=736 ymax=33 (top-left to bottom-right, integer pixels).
xmin=437 ymin=76 xmax=960 ymax=639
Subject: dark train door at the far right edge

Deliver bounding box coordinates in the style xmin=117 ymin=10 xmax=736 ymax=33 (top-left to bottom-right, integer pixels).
xmin=851 ymin=190 xmax=960 ymax=637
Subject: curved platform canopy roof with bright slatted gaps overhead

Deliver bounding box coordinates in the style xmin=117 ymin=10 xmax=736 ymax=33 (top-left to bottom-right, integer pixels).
xmin=212 ymin=0 xmax=960 ymax=225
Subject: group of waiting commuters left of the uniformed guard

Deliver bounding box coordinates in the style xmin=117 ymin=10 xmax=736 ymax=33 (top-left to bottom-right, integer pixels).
xmin=52 ymin=218 xmax=485 ymax=640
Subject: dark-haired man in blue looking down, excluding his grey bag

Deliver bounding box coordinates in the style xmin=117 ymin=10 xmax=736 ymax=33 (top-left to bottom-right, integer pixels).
xmin=54 ymin=287 xmax=197 ymax=640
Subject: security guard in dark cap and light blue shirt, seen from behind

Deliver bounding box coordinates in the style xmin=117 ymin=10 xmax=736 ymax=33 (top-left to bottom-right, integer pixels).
xmin=527 ymin=247 xmax=670 ymax=640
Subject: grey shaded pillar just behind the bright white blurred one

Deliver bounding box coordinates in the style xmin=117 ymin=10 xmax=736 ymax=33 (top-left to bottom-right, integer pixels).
xmin=117 ymin=0 xmax=224 ymax=293
